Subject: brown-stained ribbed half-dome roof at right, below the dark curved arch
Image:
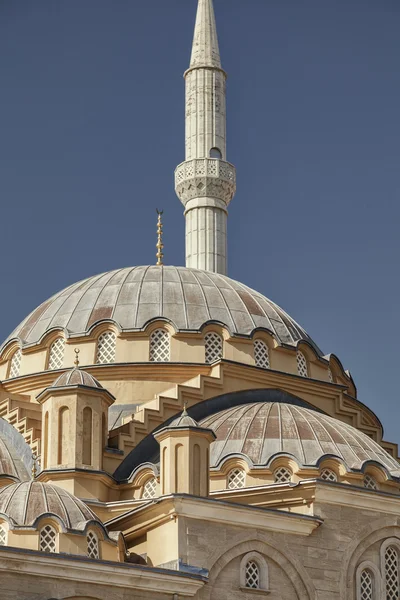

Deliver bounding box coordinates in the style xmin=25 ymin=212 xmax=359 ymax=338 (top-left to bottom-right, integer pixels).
xmin=200 ymin=402 xmax=400 ymax=477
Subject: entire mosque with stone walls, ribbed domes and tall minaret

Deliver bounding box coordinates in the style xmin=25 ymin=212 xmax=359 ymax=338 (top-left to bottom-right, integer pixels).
xmin=0 ymin=0 xmax=400 ymax=600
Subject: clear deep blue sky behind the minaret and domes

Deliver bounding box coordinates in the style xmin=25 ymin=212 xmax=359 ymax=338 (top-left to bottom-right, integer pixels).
xmin=0 ymin=0 xmax=400 ymax=442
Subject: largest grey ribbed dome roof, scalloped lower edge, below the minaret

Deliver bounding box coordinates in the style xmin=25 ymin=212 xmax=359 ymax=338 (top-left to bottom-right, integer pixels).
xmin=3 ymin=266 xmax=321 ymax=354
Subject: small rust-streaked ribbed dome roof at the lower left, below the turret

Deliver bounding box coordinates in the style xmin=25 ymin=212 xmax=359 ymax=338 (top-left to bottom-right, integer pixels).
xmin=0 ymin=481 xmax=98 ymax=530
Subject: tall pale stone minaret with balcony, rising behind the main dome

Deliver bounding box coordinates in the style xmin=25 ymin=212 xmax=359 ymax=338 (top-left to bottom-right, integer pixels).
xmin=175 ymin=0 xmax=236 ymax=274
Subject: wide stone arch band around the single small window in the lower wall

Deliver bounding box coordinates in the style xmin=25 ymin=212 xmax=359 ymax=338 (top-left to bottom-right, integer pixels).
xmin=204 ymin=533 xmax=316 ymax=600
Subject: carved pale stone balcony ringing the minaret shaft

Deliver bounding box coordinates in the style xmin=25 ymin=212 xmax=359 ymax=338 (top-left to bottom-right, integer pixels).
xmin=175 ymin=158 xmax=236 ymax=209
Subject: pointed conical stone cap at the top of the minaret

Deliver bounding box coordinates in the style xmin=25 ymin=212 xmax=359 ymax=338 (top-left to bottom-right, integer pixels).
xmin=190 ymin=0 xmax=221 ymax=69
